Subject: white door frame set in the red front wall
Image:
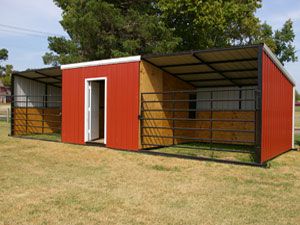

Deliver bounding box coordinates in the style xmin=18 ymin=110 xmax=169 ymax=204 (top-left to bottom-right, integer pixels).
xmin=84 ymin=77 xmax=107 ymax=144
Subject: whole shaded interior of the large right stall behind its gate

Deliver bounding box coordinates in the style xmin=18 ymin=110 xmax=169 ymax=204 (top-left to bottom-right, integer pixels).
xmin=140 ymin=45 xmax=260 ymax=162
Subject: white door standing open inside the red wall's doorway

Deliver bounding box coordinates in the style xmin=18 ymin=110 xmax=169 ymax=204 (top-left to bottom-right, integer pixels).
xmin=88 ymin=81 xmax=100 ymax=141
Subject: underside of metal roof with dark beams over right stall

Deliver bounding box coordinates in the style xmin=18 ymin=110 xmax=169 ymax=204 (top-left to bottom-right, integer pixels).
xmin=142 ymin=45 xmax=258 ymax=87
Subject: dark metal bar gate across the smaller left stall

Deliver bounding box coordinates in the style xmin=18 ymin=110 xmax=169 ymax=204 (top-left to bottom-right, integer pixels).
xmin=11 ymin=95 xmax=61 ymax=141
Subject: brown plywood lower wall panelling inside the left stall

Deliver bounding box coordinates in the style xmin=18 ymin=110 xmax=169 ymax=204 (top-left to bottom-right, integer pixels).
xmin=14 ymin=108 xmax=61 ymax=135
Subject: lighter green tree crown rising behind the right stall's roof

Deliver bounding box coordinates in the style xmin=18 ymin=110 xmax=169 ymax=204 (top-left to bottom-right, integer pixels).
xmin=159 ymin=0 xmax=261 ymax=50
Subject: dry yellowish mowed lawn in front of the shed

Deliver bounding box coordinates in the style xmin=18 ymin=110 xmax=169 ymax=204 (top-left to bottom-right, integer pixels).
xmin=0 ymin=123 xmax=300 ymax=225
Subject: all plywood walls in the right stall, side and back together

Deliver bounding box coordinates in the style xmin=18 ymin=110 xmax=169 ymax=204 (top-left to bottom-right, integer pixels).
xmin=139 ymin=61 xmax=255 ymax=148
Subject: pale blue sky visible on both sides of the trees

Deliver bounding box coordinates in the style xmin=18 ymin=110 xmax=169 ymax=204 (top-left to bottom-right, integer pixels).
xmin=0 ymin=0 xmax=300 ymax=90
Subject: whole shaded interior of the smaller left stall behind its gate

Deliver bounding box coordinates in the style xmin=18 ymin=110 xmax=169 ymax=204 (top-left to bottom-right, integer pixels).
xmin=11 ymin=67 xmax=62 ymax=141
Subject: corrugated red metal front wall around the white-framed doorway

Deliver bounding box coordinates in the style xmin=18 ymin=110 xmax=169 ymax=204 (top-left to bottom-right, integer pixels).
xmin=62 ymin=62 xmax=139 ymax=150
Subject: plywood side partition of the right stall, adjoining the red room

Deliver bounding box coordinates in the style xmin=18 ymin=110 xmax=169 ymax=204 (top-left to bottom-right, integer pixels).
xmin=139 ymin=61 xmax=194 ymax=148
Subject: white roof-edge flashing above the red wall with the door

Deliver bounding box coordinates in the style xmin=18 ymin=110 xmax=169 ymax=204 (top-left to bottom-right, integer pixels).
xmin=60 ymin=55 xmax=141 ymax=70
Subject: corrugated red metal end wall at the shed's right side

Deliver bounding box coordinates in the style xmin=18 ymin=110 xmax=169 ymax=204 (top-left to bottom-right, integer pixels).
xmin=261 ymin=52 xmax=293 ymax=162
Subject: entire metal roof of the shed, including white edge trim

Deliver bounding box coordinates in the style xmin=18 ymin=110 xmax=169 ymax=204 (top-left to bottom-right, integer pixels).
xmin=13 ymin=44 xmax=295 ymax=87
